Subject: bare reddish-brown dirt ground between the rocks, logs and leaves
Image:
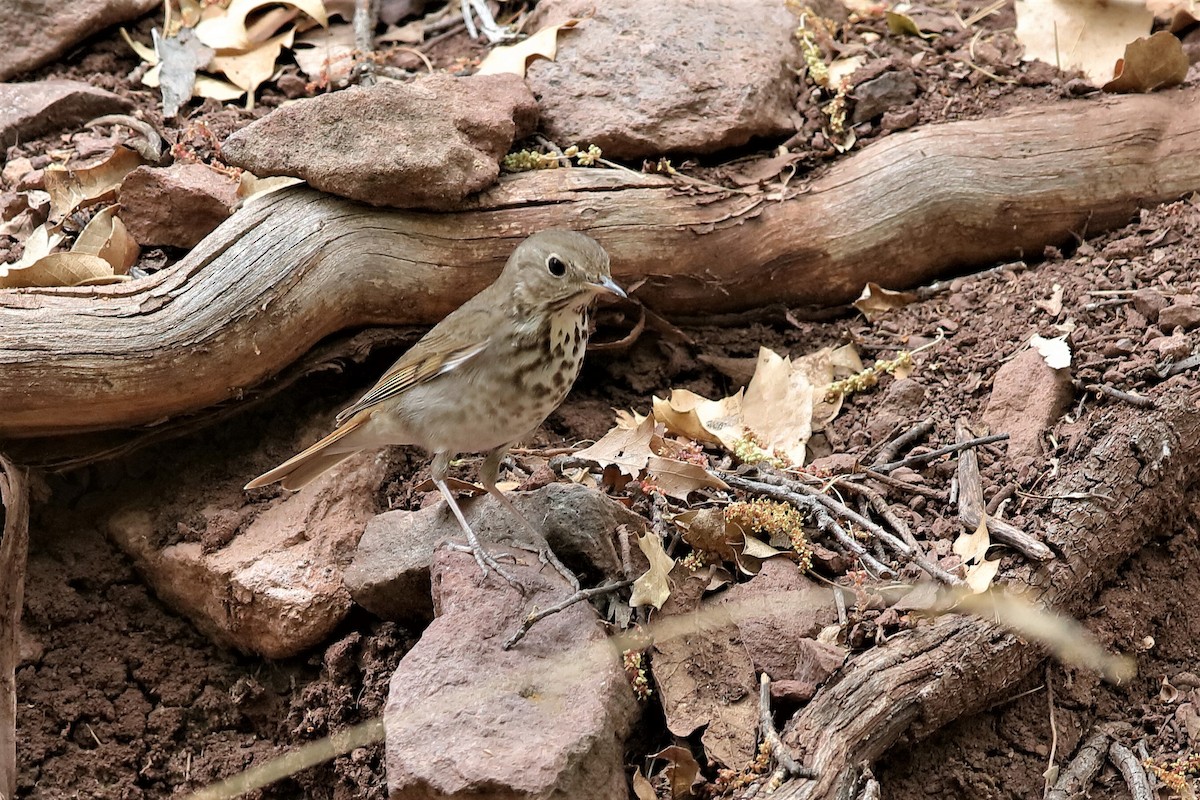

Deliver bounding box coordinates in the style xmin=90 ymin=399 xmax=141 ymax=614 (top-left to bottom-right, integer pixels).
xmin=7 ymin=4 xmax=1200 ymax=800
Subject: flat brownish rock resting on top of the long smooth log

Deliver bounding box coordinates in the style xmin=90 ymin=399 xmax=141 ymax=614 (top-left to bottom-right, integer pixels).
xmin=222 ymin=74 xmax=538 ymax=210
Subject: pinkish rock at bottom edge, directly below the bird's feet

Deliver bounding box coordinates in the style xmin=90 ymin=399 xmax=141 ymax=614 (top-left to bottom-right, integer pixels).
xmin=384 ymin=548 xmax=637 ymax=800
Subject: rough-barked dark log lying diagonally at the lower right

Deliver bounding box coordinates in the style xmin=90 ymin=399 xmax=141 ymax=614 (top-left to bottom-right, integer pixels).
xmin=773 ymin=391 xmax=1200 ymax=800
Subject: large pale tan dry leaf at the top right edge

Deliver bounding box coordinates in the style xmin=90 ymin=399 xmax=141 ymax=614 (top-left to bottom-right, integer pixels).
xmin=1016 ymin=0 xmax=1154 ymax=85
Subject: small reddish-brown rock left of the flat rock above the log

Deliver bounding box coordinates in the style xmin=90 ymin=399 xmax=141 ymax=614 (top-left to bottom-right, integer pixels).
xmin=120 ymin=164 xmax=239 ymax=247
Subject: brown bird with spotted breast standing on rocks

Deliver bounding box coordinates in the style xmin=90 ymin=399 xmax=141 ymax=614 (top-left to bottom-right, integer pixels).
xmin=246 ymin=229 xmax=626 ymax=588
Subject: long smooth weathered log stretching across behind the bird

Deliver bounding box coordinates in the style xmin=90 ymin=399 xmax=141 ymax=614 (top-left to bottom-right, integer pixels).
xmin=0 ymin=89 xmax=1200 ymax=439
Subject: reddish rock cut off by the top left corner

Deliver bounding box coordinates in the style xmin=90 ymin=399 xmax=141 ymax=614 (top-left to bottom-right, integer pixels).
xmin=0 ymin=0 xmax=161 ymax=80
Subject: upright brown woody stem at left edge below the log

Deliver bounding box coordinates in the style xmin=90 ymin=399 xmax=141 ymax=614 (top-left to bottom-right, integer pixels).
xmin=0 ymin=455 xmax=29 ymax=799
